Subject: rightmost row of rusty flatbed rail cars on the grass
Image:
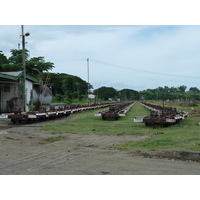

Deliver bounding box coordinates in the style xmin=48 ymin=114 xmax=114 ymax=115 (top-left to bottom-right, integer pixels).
xmin=134 ymin=103 xmax=188 ymax=126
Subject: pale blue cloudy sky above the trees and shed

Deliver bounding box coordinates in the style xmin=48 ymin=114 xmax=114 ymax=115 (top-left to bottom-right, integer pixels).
xmin=0 ymin=25 xmax=200 ymax=91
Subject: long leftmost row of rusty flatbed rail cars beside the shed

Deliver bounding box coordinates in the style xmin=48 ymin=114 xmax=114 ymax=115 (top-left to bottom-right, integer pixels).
xmin=7 ymin=102 xmax=120 ymax=124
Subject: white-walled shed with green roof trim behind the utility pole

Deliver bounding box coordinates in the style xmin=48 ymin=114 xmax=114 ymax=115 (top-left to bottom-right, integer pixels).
xmin=0 ymin=71 xmax=38 ymax=112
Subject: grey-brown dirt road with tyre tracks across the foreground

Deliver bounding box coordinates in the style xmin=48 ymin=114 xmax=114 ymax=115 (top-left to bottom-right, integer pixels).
xmin=0 ymin=116 xmax=200 ymax=175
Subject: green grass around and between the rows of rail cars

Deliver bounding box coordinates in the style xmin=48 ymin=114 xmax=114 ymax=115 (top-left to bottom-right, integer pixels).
xmin=42 ymin=103 xmax=200 ymax=151
